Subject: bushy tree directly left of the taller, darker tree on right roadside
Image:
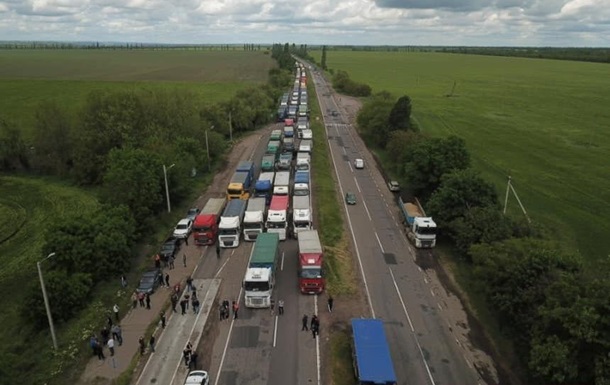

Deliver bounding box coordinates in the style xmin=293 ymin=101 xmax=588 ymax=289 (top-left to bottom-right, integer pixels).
xmin=356 ymin=92 xmax=394 ymax=148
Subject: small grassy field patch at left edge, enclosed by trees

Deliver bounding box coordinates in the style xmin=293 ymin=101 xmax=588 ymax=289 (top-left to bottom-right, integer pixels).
xmin=0 ymin=176 xmax=97 ymax=372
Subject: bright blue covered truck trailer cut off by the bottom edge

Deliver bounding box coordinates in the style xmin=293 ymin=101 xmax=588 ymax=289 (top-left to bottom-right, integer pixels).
xmin=352 ymin=318 xmax=397 ymax=385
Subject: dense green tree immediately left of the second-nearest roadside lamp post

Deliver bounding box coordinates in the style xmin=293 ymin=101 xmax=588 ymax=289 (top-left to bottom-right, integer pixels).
xmin=103 ymin=148 xmax=164 ymax=227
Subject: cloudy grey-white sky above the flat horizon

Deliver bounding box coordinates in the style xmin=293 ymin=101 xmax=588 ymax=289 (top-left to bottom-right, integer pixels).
xmin=0 ymin=0 xmax=610 ymax=47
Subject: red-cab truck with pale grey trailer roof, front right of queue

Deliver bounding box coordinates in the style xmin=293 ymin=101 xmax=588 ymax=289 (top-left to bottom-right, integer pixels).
xmin=299 ymin=230 xmax=324 ymax=294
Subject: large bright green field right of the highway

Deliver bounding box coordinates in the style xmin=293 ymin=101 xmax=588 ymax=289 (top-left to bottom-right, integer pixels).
xmin=317 ymin=51 xmax=610 ymax=264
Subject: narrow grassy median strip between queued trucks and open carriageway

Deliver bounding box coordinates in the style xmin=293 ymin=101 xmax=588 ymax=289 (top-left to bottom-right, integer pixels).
xmin=307 ymin=76 xmax=357 ymax=385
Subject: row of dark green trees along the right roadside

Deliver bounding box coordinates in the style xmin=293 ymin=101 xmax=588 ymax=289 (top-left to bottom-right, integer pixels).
xmin=358 ymin=92 xmax=610 ymax=385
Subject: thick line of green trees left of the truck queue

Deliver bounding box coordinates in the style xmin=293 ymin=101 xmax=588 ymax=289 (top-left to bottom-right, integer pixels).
xmin=0 ymin=46 xmax=294 ymax=346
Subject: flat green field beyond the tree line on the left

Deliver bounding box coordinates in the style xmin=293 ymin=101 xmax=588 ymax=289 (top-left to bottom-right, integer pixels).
xmin=0 ymin=49 xmax=274 ymax=136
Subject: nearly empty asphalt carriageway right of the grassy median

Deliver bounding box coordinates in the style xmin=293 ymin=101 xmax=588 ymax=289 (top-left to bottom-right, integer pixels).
xmin=314 ymin=67 xmax=480 ymax=385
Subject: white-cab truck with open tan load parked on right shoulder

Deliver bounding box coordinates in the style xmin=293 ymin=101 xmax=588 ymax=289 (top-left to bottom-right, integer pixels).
xmin=398 ymin=197 xmax=436 ymax=249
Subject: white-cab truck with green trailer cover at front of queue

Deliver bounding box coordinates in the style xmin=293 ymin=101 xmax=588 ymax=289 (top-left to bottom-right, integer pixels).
xmin=243 ymin=233 xmax=279 ymax=308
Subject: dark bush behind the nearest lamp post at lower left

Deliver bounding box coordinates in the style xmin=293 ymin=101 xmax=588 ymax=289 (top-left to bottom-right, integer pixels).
xmin=21 ymin=270 xmax=93 ymax=328
